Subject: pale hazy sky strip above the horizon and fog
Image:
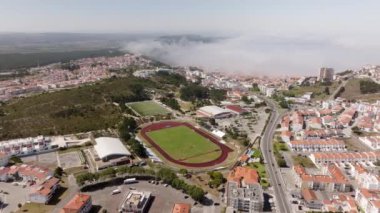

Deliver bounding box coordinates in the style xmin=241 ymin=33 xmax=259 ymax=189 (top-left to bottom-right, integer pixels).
xmin=0 ymin=0 xmax=380 ymax=35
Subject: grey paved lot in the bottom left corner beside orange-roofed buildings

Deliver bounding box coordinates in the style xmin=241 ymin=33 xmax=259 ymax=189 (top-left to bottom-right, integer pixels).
xmin=0 ymin=182 xmax=30 ymax=213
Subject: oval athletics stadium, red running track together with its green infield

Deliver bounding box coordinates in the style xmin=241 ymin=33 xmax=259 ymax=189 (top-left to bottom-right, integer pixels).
xmin=141 ymin=121 xmax=232 ymax=168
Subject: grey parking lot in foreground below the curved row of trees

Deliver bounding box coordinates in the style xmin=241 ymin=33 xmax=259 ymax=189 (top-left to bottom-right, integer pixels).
xmin=85 ymin=181 xmax=208 ymax=213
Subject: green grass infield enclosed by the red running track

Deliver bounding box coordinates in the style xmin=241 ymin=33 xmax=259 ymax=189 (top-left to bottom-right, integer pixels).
xmin=147 ymin=126 xmax=221 ymax=163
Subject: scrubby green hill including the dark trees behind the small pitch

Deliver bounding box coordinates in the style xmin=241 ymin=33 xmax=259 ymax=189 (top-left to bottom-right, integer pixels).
xmin=0 ymin=65 xmax=229 ymax=140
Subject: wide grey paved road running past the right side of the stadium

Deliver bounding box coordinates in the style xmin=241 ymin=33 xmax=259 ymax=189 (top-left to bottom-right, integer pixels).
xmin=260 ymin=100 xmax=293 ymax=213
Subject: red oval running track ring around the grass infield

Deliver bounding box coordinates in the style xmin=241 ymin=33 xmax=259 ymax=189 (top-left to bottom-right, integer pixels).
xmin=141 ymin=121 xmax=233 ymax=168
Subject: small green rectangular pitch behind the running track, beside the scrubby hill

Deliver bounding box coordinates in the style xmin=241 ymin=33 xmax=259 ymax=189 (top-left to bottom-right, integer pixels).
xmin=126 ymin=101 xmax=170 ymax=116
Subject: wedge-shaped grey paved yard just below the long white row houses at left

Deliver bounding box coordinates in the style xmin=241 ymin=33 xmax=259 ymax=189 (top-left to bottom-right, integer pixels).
xmin=21 ymin=152 xmax=57 ymax=169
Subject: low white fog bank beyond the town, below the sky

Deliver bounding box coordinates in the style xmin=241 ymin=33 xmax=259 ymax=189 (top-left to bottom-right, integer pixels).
xmin=124 ymin=35 xmax=380 ymax=76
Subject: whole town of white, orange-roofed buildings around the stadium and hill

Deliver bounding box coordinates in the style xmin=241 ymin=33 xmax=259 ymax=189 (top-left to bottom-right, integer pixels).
xmin=0 ymin=53 xmax=380 ymax=213
